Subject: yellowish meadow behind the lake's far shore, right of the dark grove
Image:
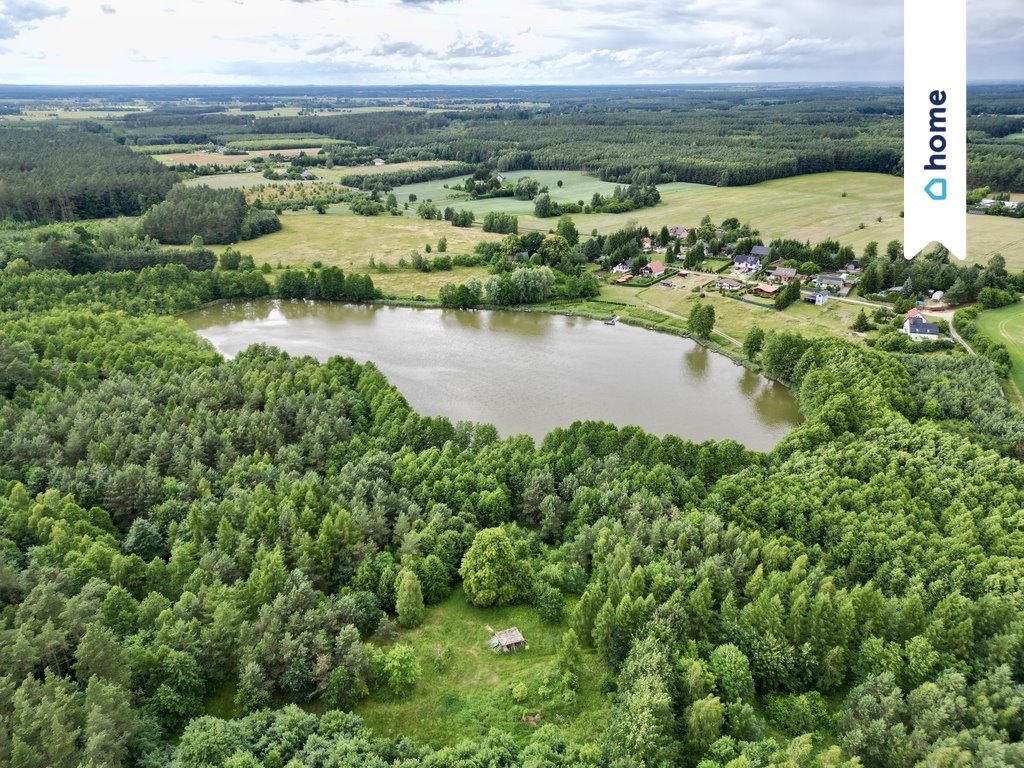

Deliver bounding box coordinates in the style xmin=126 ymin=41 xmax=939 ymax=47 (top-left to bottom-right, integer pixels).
xmin=229 ymin=208 xmax=502 ymax=299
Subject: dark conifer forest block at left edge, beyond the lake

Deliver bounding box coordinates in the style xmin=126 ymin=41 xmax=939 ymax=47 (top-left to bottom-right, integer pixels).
xmin=0 ymin=126 xmax=177 ymax=223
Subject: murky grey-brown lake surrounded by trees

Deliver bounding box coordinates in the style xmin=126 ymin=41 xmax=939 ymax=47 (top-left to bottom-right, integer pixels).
xmin=184 ymin=300 xmax=801 ymax=451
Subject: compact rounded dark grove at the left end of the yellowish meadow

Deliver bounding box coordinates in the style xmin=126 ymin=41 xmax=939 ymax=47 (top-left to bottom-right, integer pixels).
xmin=142 ymin=185 xmax=281 ymax=245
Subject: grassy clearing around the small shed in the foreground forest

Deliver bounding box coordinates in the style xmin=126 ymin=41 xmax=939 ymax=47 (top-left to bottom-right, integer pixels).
xmin=355 ymin=589 xmax=608 ymax=746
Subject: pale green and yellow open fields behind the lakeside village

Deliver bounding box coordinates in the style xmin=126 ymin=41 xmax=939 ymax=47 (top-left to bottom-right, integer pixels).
xmin=394 ymin=171 xmax=1024 ymax=270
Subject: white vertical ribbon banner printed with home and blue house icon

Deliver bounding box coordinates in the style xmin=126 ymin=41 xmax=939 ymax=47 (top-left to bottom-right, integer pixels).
xmin=903 ymin=0 xmax=967 ymax=259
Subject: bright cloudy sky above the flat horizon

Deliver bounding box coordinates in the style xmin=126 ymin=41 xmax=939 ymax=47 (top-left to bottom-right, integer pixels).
xmin=0 ymin=0 xmax=1024 ymax=85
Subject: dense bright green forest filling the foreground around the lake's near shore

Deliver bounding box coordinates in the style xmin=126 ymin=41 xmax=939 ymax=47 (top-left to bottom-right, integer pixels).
xmin=0 ymin=246 xmax=1024 ymax=768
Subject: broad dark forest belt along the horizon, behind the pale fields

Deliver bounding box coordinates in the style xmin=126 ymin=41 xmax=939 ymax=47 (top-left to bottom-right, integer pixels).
xmin=101 ymin=87 xmax=1024 ymax=191
